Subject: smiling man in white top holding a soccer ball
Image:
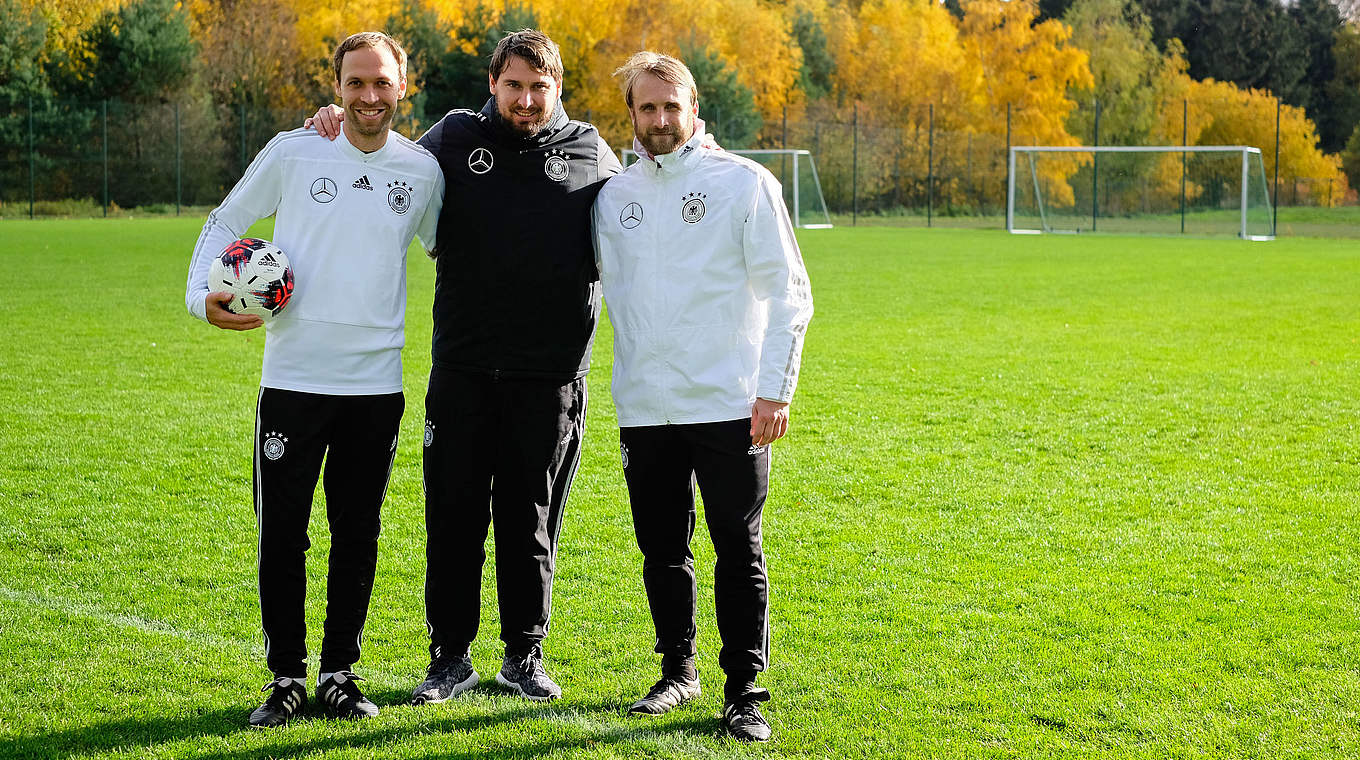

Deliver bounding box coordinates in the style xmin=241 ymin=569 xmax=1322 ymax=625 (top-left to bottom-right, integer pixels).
xmin=185 ymin=33 xmax=443 ymax=727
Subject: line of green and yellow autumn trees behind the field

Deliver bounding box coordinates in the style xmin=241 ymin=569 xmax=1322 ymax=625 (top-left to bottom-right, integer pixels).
xmin=0 ymin=0 xmax=1360 ymax=210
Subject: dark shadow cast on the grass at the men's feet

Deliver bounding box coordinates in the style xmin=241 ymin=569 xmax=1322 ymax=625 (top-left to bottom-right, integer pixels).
xmin=0 ymin=689 xmax=718 ymax=760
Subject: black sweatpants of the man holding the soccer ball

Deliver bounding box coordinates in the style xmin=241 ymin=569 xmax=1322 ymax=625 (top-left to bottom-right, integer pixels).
xmin=254 ymin=387 xmax=405 ymax=678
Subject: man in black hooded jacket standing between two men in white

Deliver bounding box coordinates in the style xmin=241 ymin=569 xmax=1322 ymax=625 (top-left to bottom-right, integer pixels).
xmin=317 ymin=30 xmax=622 ymax=704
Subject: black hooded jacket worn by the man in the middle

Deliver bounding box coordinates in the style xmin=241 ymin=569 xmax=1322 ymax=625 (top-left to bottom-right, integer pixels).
xmin=419 ymin=98 xmax=622 ymax=379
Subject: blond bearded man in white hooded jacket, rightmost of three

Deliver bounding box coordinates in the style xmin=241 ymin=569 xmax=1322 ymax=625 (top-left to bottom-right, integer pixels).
xmin=594 ymin=52 xmax=812 ymax=741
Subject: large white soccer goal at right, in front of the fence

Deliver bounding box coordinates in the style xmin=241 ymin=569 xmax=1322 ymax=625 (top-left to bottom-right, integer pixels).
xmin=1006 ymin=145 xmax=1274 ymax=241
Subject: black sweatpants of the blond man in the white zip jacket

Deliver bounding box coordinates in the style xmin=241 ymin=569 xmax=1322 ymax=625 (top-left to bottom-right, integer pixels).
xmin=619 ymin=419 xmax=770 ymax=673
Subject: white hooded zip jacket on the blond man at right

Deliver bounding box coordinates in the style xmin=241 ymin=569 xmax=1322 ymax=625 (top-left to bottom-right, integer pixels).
xmin=594 ymin=126 xmax=812 ymax=427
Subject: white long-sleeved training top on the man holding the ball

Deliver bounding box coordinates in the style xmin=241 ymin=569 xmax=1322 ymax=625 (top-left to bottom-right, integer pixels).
xmin=185 ymin=129 xmax=443 ymax=396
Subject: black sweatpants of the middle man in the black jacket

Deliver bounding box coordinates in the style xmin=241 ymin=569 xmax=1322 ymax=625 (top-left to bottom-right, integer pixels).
xmin=424 ymin=368 xmax=586 ymax=657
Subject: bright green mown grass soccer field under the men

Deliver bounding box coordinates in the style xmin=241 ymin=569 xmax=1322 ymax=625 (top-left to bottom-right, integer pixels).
xmin=0 ymin=219 xmax=1360 ymax=760
